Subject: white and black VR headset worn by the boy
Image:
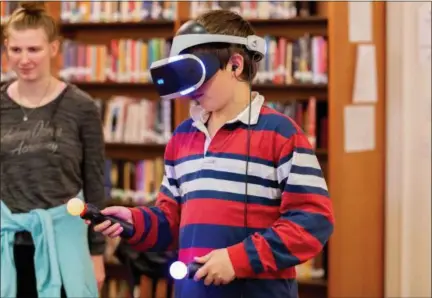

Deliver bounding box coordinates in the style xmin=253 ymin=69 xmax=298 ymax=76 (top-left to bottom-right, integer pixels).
xmin=150 ymin=21 xmax=266 ymax=99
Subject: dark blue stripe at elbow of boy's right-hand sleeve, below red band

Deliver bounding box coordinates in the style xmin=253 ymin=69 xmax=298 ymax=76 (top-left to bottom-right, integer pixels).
xmin=282 ymin=210 xmax=333 ymax=246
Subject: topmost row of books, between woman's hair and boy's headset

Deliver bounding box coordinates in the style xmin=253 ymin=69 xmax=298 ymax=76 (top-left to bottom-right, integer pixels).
xmin=60 ymin=0 xmax=177 ymax=23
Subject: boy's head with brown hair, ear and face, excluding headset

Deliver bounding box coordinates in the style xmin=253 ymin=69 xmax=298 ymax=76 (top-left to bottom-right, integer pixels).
xmin=180 ymin=10 xmax=258 ymax=112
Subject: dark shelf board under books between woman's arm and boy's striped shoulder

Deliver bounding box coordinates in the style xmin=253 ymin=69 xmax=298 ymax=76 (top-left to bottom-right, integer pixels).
xmin=105 ymin=143 xmax=165 ymax=161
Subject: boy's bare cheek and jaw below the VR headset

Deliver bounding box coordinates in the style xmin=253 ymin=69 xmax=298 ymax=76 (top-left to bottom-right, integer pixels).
xmin=184 ymin=63 xmax=238 ymax=112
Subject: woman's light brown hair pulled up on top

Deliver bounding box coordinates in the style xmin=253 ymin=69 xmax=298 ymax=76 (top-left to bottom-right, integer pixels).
xmin=3 ymin=1 xmax=59 ymax=42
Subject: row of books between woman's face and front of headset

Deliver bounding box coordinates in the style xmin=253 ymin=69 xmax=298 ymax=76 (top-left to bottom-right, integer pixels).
xmin=60 ymin=38 xmax=171 ymax=83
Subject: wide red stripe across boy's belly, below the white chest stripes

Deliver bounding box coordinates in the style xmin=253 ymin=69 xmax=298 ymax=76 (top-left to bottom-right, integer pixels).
xmin=181 ymin=199 xmax=280 ymax=228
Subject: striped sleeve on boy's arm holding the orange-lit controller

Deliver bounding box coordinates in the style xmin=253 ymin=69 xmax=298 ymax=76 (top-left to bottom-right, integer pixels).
xmin=128 ymin=142 xmax=181 ymax=251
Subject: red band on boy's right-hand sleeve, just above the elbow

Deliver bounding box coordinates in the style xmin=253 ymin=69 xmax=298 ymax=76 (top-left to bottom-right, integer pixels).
xmin=281 ymin=192 xmax=334 ymax=223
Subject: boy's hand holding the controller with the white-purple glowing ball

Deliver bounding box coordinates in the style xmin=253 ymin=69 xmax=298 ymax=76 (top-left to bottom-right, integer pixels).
xmin=195 ymin=248 xmax=235 ymax=286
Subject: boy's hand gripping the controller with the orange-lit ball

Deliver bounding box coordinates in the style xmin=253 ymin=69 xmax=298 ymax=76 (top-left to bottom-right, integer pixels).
xmin=86 ymin=206 xmax=133 ymax=238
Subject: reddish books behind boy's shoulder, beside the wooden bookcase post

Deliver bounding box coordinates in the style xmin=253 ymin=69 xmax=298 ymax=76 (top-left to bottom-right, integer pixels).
xmin=266 ymin=97 xmax=328 ymax=149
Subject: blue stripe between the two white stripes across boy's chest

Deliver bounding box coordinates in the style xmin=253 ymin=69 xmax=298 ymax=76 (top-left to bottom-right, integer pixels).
xmin=178 ymin=169 xmax=278 ymax=188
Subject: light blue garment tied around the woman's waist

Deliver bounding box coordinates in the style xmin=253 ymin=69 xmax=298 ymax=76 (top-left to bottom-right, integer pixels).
xmin=1 ymin=194 xmax=99 ymax=298
